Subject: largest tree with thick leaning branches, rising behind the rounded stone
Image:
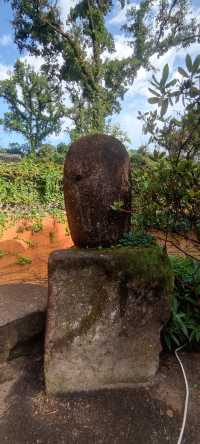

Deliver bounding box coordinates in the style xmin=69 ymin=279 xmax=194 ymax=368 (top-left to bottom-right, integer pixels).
xmin=8 ymin=0 xmax=200 ymax=134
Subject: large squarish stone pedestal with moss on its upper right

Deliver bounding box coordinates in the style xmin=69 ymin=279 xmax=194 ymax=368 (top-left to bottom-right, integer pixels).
xmin=45 ymin=245 xmax=173 ymax=394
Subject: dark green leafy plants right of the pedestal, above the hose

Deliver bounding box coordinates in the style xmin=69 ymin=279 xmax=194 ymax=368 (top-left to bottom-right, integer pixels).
xmin=163 ymin=256 xmax=200 ymax=350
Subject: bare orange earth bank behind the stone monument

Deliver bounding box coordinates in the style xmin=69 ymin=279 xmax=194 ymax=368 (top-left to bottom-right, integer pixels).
xmin=0 ymin=216 xmax=200 ymax=284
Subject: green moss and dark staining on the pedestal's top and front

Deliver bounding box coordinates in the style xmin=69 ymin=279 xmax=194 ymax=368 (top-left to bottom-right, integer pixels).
xmin=50 ymin=244 xmax=173 ymax=347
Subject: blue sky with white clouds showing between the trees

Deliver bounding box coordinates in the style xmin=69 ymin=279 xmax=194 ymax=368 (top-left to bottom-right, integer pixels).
xmin=0 ymin=0 xmax=200 ymax=148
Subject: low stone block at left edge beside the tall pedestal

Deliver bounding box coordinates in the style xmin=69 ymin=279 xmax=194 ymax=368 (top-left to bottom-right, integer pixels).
xmin=0 ymin=283 xmax=47 ymax=363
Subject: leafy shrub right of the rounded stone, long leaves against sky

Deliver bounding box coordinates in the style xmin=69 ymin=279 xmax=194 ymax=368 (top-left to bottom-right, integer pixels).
xmin=132 ymin=55 xmax=200 ymax=232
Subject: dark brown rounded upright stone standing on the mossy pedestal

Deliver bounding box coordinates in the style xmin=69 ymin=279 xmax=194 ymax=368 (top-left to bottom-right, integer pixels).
xmin=64 ymin=134 xmax=131 ymax=247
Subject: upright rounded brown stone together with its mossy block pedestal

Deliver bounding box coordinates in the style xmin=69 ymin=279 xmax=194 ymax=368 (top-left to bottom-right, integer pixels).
xmin=44 ymin=135 xmax=173 ymax=395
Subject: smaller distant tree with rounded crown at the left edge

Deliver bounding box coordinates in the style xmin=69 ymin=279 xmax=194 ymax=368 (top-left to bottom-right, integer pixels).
xmin=0 ymin=60 xmax=66 ymax=152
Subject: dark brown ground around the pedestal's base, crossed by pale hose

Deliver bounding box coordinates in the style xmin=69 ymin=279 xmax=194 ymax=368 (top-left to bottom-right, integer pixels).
xmin=0 ymin=351 xmax=200 ymax=444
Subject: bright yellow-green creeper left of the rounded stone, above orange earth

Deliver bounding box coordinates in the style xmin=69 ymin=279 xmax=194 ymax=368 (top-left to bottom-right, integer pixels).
xmin=0 ymin=158 xmax=64 ymax=210
